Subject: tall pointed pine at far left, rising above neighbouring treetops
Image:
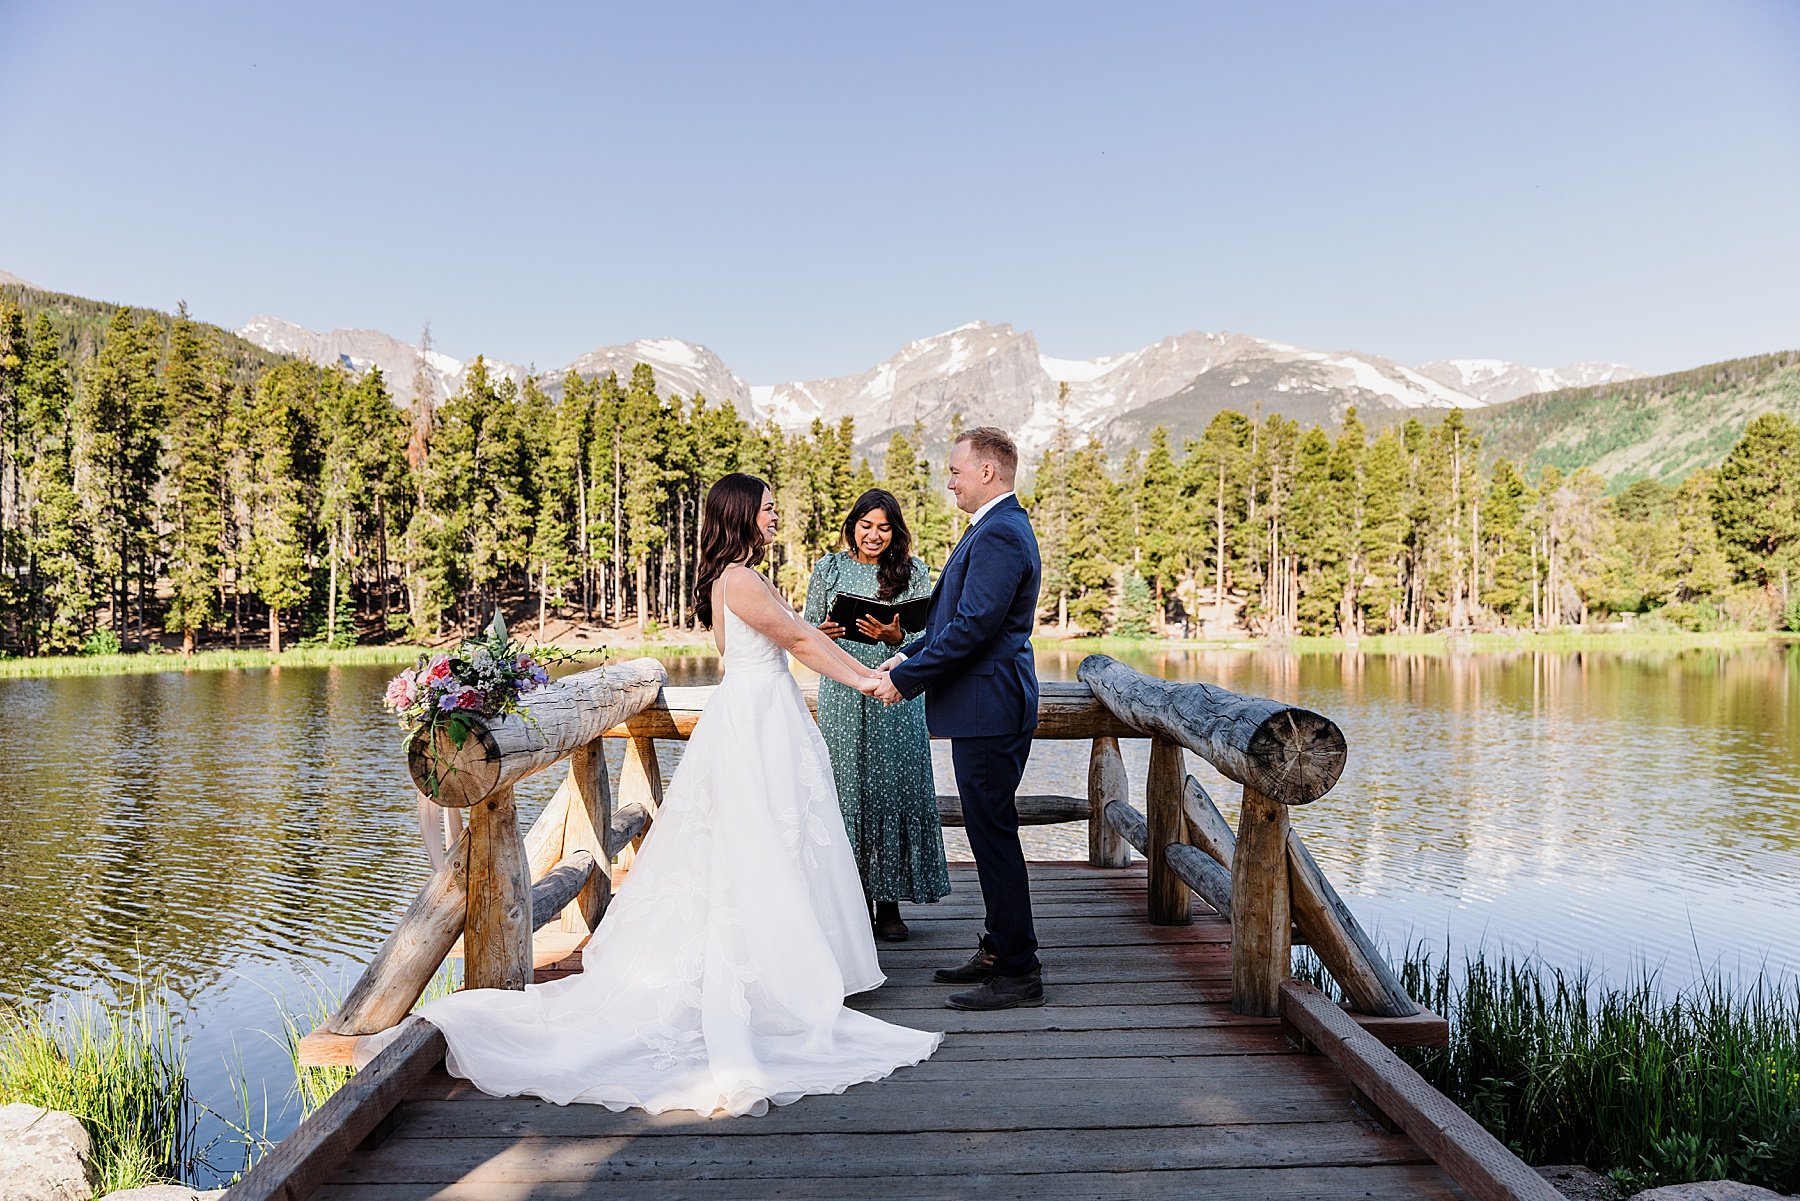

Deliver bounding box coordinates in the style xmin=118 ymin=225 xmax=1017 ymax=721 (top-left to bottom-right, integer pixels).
xmin=162 ymin=304 xmax=230 ymax=655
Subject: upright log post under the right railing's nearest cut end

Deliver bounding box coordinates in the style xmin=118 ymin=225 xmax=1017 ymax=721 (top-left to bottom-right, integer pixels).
xmin=1231 ymin=785 xmax=1292 ymax=1017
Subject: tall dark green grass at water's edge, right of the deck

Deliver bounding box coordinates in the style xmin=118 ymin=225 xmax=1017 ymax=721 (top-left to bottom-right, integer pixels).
xmin=1296 ymin=947 xmax=1800 ymax=1194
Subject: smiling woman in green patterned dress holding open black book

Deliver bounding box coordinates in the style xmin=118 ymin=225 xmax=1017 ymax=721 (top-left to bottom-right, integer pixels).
xmin=805 ymin=488 xmax=950 ymax=942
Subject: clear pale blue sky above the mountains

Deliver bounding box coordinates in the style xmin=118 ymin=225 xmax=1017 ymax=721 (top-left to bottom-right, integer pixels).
xmin=0 ymin=0 xmax=1800 ymax=384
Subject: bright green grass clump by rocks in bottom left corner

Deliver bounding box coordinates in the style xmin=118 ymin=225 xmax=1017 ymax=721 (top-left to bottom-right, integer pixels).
xmin=0 ymin=989 xmax=194 ymax=1194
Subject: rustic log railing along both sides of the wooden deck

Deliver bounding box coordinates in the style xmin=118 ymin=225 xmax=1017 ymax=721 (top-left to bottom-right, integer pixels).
xmin=315 ymin=655 xmax=1420 ymax=1057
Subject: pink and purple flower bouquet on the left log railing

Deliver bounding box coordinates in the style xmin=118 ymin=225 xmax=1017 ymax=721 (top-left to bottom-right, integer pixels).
xmin=382 ymin=610 xmax=581 ymax=749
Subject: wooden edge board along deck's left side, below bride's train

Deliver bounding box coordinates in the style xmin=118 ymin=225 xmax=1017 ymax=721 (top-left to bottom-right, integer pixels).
xmin=230 ymin=1019 xmax=445 ymax=1201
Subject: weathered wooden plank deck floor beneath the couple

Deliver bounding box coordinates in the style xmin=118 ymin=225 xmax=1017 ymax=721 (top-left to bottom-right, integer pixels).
xmin=315 ymin=861 xmax=1465 ymax=1201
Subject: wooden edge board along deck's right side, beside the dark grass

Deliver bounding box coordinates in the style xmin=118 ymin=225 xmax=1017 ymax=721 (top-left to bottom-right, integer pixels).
xmin=1282 ymin=980 xmax=1562 ymax=1201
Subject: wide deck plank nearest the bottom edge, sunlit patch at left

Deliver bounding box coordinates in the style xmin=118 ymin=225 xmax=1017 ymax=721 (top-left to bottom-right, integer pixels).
xmin=338 ymin=1122 xmax=1422 ymax=1185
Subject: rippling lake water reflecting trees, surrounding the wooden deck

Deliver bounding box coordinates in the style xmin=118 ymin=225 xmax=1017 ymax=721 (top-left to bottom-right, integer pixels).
xmin=0 ymin=646 xmax=1800 ymax=1179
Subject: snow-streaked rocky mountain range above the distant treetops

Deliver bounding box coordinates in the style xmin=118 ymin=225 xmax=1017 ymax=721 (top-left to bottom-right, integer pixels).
xmin=238 ymin=317 xmax=1642 ymax=454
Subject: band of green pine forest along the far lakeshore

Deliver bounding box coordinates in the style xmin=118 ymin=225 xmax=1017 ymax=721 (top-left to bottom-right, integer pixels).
xmin=0 ymin=293 xmax=1800 ymax=654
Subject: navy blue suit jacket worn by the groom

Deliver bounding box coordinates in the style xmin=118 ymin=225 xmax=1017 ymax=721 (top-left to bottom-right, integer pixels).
xmin=891 ymin=497 xmax=1042 ymax=738
